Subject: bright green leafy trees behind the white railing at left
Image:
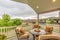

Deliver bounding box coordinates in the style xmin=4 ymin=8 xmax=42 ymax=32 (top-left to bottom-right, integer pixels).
xmin=0 ymin=14 xmax=22 ymax=27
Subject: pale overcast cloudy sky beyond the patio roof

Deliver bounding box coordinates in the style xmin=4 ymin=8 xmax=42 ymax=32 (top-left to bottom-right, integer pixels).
xmin=0 ymin=0 xmax=58 ymax=19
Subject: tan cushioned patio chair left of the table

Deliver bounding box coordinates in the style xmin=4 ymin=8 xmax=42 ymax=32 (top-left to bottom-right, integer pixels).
xmin=15 ymin=27 xmax=29 ymax=40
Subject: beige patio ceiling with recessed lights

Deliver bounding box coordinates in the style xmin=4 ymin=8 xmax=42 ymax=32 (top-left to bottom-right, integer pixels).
xmin=14 ymin=0 xmax=60 ymax=14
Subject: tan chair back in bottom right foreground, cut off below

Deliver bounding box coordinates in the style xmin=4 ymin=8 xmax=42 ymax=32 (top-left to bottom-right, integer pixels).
xmin=39 ymin=34 xmax=60 ymax=40
